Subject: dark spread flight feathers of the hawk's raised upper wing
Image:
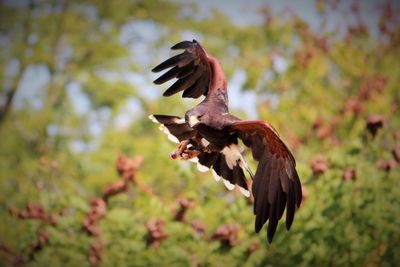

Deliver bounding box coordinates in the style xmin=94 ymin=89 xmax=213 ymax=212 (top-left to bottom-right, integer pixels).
xmin=152 ymin=40 xmax=211 ymax=98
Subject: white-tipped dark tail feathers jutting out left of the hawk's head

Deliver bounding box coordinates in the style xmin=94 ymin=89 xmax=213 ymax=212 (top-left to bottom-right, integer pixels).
xmin=149 ymin=115 xmax=196 ymax=143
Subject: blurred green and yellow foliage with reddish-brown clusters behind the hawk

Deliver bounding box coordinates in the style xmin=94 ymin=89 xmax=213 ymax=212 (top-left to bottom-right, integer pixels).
xmin=0 ymin=0 xmax=400 ymax=266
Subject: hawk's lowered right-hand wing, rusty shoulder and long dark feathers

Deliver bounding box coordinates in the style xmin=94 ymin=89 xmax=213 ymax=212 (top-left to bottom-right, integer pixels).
xmin=229 ymin=121 xmax=302 ymax=242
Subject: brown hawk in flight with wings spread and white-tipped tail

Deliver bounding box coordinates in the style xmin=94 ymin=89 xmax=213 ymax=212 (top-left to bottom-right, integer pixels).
xmin=149 ymin=40 xmax=302 ymax=243
